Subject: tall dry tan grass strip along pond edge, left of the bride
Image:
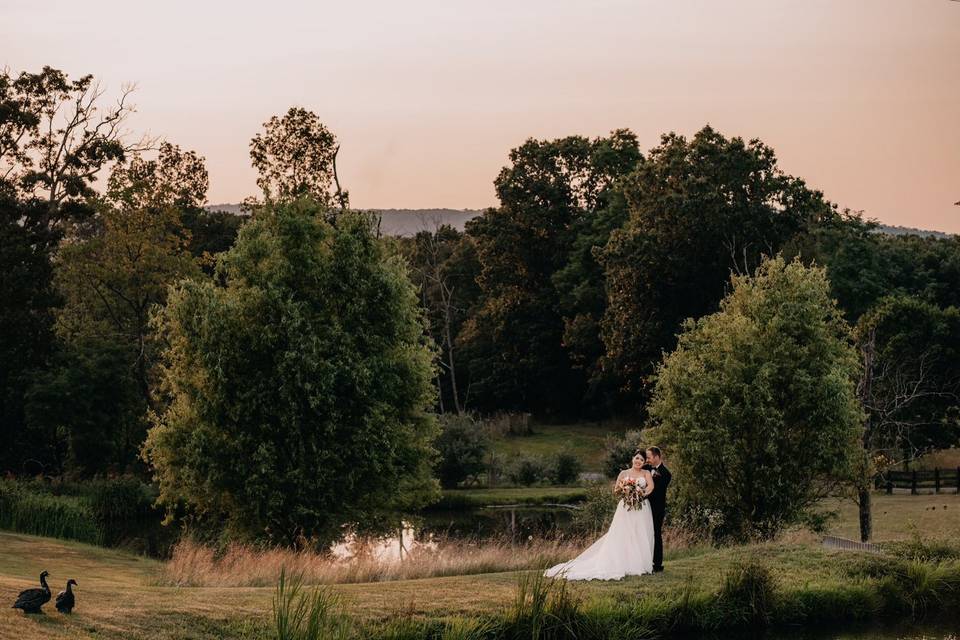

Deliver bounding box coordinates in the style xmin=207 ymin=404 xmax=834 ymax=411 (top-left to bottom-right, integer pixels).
xmin=157 ymin=540 xmax=586 ymax=587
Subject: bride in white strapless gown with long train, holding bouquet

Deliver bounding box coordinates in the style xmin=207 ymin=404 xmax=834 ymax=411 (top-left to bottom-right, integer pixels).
xmin=544 ymin=451 xmax=654 ymax=580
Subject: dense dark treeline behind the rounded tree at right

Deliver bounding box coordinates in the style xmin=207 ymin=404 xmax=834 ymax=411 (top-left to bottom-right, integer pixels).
xmin=404 ymin=127 xmax=960 ymax=428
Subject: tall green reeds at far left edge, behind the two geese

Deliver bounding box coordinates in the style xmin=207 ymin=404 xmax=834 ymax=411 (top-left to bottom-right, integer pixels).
xmin=0 ymin=477 xmax=159 ymax=544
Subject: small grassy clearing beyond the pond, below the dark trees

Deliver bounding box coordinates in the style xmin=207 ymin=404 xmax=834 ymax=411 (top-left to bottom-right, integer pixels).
xmin=493 ymin=422 xmax=624 ymax=472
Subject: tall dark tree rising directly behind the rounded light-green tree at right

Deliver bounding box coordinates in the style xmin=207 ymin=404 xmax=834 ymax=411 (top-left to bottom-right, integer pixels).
xmin=602 ymin=126 xmax=831 ymax=401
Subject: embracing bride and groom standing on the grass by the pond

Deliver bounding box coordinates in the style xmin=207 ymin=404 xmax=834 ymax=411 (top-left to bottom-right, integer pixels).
xmin=545 ymin=447 xmax=670 ymax=580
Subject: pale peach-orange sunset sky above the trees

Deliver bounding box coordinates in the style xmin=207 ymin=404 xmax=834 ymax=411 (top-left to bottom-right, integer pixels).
xmin=7 ymin=0 xmax=960 ymax=233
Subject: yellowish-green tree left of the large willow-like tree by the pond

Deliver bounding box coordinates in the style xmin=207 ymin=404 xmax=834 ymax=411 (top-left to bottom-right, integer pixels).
xmin=56 ymin=145 xmax=207 ymax=404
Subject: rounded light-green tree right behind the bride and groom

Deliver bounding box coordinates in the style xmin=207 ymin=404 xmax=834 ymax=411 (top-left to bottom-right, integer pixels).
xmin=650 ymin=257 xmax=863 ymax=541
